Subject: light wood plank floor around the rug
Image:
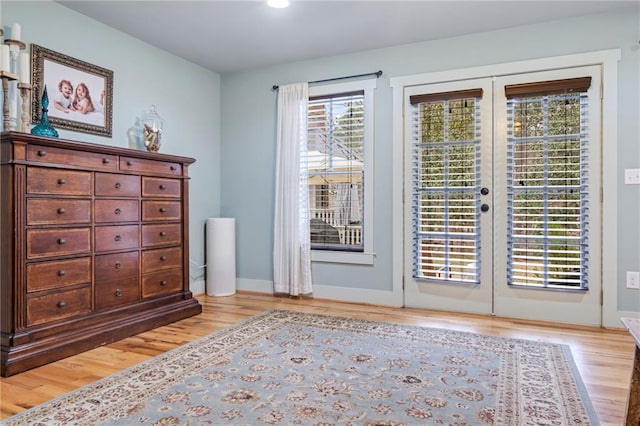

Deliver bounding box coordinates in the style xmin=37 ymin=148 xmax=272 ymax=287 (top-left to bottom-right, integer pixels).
xmin=0 ymin=293 xmax=634 ymax=426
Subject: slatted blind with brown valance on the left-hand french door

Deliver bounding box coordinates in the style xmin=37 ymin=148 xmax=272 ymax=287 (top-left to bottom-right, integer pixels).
xmin=410 ymin=89 xmax=482 ymax=283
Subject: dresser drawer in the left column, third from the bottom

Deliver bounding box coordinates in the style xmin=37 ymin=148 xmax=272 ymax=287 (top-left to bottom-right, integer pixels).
xmin=27 ymin=228 xmax=91 ymax=259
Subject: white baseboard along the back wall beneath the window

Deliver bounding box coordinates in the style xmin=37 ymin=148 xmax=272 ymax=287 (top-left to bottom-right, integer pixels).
xmin=237 ymin=278 xmax=402 ymax=307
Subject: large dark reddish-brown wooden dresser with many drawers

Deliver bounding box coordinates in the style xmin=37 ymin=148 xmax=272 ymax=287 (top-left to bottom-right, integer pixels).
xmin=0 ymin=132 xmax=202 ymax=376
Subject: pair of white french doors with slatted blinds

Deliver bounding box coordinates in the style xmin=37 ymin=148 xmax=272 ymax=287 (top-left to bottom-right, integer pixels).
xmin=404 ymin=66 xmax=601 ymax=325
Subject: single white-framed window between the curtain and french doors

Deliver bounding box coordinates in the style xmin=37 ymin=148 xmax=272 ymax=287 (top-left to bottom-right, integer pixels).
xmin=300 ymin=81 xmax=375 ymax=263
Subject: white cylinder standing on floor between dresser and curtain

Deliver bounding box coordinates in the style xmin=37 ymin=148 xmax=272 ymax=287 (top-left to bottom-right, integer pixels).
xmin=205 ymin=217 xmax=236 ymax=296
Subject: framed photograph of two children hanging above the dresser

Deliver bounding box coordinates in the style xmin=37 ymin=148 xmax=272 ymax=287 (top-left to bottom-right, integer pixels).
xmin=31 ymin=44 xmax=113 ymax=136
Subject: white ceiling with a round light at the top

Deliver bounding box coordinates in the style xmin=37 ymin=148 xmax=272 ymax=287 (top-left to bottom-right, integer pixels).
xmin=58 ymin=0 xmax=638 ymax=73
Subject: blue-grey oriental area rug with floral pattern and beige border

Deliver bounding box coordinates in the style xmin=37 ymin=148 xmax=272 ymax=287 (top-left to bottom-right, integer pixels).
xmin=2 ymin=310 xmax=598 ymax=426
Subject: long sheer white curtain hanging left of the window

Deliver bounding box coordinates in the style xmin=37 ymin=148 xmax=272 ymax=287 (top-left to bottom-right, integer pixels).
xmin=273 ymin=83 xmax=312 ymax=296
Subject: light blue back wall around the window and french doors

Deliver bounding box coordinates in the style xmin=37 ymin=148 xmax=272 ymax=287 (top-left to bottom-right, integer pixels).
xmin=221 ymin=8 xmax=640 ymax=311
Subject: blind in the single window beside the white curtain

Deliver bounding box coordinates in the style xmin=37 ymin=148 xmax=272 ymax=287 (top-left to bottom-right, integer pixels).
xmin=301 ymin=91 xmax=365 ymax=252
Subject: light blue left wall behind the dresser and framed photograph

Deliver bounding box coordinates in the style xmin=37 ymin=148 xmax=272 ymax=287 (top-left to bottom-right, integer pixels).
xmin=0 ymin=1 xmax=220 ymax=290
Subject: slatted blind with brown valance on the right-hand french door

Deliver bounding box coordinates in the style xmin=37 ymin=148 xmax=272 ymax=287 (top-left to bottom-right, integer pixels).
xmin=505 ymin=77 xmax=591 ymax=289
